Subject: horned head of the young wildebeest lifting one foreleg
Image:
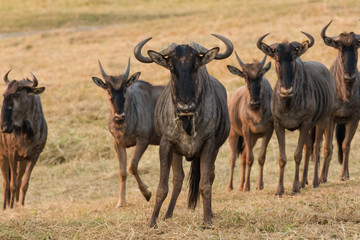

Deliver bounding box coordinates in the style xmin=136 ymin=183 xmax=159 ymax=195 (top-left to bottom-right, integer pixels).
xmin=92 ymin=59 xmax=141 ymax=123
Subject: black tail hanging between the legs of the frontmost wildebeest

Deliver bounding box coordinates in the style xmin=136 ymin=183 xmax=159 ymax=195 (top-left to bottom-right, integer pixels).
xmin=188 ymin=157 xmax=200 ymax=209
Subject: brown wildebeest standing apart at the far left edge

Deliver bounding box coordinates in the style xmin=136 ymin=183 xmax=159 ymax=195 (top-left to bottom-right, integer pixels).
xmin=0 ymin=71 xmax=47 ymax=209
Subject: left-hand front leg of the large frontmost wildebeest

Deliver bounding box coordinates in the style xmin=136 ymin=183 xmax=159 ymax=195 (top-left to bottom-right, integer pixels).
xmin=150 ymin=138 xmax=172 ymax=227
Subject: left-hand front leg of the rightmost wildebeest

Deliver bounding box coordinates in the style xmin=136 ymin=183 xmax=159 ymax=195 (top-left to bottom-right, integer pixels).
xmin=320 ymin=120 xmax=335 ymax=183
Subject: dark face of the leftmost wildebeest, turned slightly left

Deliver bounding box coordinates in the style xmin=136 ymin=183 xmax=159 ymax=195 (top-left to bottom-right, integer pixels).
xmin=1 ymin=80 xmax=45 ymax=133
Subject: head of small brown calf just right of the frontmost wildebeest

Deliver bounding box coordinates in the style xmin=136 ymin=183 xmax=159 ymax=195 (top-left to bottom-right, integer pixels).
xmin=227 ymin=55 xmax=271 ymax=109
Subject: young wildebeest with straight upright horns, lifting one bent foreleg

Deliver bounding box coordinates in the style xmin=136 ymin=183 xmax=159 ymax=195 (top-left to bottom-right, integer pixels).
xmin=92 ymin=59 xmax=164 ymax=208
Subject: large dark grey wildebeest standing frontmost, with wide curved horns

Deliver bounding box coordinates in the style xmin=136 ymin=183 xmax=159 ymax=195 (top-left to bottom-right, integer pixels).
xmin=135 ymin=34 xmax=233 ymax=227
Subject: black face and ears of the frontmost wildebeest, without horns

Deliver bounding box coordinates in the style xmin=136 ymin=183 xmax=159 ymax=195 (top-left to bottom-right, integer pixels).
xmin=148 ymin=45 xmax=219 ymax=114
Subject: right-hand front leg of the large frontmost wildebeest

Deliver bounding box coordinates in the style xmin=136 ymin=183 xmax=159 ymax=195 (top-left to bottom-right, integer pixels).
xmin=199 ymin=137 xmax=216 ymax=225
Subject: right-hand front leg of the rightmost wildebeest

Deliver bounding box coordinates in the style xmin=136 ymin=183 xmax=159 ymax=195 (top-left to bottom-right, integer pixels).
xmin=341 ymin=120 xmax=359 ymax=181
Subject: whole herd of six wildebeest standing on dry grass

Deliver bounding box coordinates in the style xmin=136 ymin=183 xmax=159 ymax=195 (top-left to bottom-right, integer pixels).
xmin=0 ymin=22 xmax=360 ymax=227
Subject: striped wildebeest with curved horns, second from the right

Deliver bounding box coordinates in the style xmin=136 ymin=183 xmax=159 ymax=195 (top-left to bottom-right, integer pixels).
xmin=257 ymin=32 xmax=336 ymax=195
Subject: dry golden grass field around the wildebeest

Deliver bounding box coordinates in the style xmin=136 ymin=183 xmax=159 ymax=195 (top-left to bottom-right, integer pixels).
xmin=0 ymin=0 xmax=360 ymax=239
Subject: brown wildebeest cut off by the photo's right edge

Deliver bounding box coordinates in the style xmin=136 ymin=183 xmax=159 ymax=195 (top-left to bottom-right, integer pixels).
xmin=320 ymin=21 xmax=360 ymax=182
